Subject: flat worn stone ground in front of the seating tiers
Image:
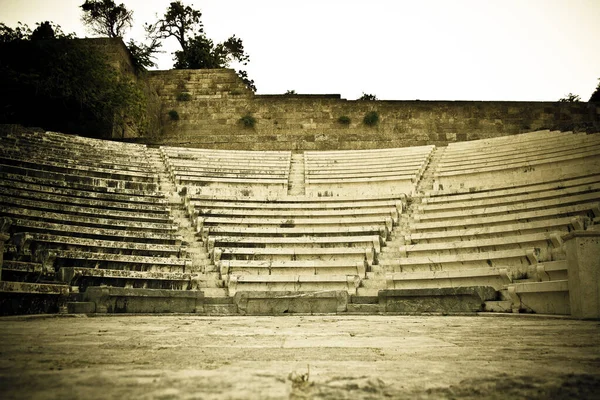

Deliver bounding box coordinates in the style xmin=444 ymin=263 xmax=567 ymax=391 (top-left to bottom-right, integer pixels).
xmin=0 ymin=316 xmax=600 ymax=399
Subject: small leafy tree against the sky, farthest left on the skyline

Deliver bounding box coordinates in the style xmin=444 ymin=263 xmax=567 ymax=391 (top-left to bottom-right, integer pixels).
xmin=80 ymin=0 xmax=133 ymax=38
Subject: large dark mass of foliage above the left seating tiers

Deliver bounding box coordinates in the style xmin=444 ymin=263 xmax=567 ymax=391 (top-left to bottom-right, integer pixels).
xmin=0 ymin=22 xmax=146 ymax=136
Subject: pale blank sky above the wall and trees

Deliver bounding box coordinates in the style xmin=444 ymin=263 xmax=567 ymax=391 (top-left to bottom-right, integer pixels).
xmin=0 ymin=0 xmax=600 ymax=101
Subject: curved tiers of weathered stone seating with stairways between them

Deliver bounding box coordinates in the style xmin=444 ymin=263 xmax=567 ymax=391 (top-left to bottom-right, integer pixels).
xmin=0 ymin=126 xmax=600 ymax=318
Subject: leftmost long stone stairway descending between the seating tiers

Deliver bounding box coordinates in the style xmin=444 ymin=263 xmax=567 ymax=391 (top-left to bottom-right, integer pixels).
xmin=147 ymin=148 xmax=233 ymax=314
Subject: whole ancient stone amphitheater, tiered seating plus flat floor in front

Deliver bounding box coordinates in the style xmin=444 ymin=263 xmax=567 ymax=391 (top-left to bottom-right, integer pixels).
xmin=0 ymin=65 xmax=600 ymax=399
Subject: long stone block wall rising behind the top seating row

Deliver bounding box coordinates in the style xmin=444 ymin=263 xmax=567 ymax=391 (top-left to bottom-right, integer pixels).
xmin=148 ymin=69 xmax=600 ymax=150
